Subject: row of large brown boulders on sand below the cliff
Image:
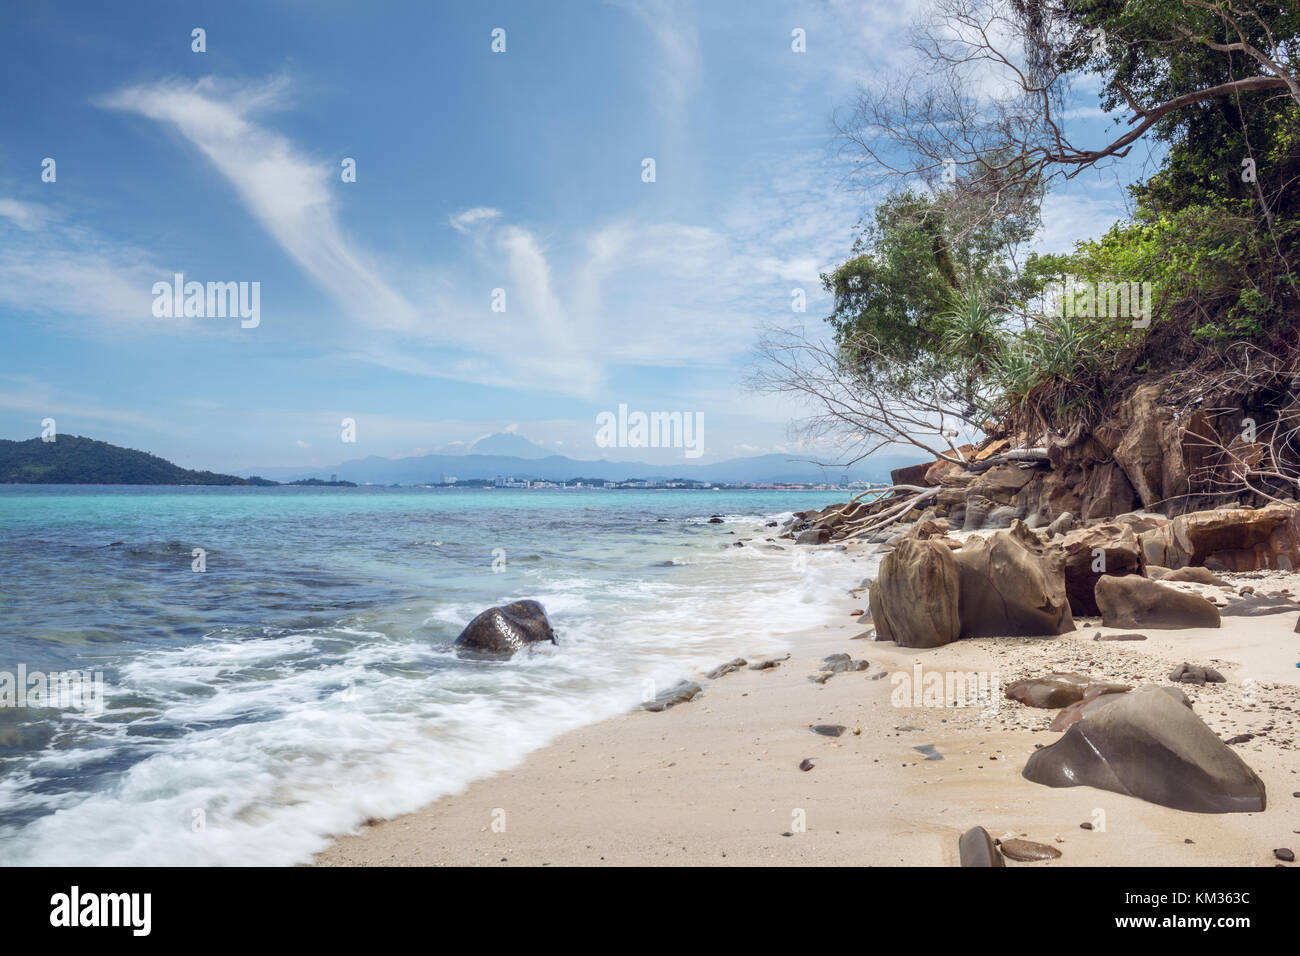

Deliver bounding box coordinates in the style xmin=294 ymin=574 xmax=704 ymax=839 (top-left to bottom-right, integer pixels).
xmin=852 ymin=506 xmax=1300 ymax=648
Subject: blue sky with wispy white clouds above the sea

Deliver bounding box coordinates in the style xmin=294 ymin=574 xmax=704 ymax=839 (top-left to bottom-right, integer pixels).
xmin=0 ymin=0 xmax=1159 ymax=473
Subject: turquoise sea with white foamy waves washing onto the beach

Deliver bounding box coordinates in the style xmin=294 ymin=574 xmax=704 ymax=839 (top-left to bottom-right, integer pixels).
xmin=0 ymin=486 xmax=862 ymax=865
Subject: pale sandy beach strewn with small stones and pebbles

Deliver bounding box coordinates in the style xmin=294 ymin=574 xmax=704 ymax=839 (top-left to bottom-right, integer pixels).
xmin=313 ymin=546 xmax=1300 ymax=866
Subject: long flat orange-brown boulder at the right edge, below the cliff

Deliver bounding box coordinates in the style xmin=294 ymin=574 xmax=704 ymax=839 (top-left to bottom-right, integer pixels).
xmin=1139 ymin=503 xmax=1300 ymax=571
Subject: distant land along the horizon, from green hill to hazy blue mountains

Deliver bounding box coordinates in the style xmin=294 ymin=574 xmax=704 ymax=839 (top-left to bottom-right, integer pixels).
xmin=0 ymin=433 xmax=915 ymax=485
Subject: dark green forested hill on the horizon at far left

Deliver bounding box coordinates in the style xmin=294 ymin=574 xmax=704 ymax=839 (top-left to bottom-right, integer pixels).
xmin=0 ymin=434 xmax=250 ymax=485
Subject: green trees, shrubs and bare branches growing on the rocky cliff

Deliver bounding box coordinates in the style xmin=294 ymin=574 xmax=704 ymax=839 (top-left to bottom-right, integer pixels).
xmin=755 ymin=0 xmax=1300 ymax=507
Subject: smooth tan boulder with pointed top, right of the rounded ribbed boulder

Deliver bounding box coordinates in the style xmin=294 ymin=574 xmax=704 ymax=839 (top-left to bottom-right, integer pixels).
xmin=953 ymin=522 xmax=1074 ymax=637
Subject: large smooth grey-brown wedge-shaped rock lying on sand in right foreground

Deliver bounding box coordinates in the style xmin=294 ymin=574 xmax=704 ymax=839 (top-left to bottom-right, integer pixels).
xmin=1024 ymin=686 xmax=1266 ymax=813
